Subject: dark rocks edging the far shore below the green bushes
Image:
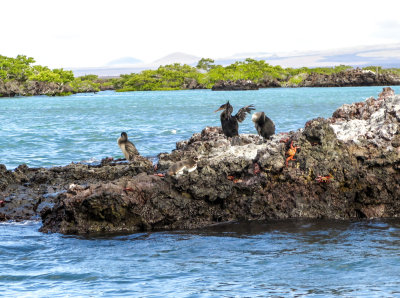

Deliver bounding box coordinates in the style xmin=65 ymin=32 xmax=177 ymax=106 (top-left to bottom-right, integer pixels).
xmin=0 ymin=68 xmax=400 ymax=97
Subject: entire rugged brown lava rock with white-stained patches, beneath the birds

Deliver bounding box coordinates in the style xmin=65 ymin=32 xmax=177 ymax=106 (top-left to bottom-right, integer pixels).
xmin=0 ymin=88 xmax=400 ymax=234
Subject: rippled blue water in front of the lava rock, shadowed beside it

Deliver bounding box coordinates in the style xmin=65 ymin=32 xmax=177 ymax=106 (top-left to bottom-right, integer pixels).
xmin=0 ymin=220 xmax=400 ymax=297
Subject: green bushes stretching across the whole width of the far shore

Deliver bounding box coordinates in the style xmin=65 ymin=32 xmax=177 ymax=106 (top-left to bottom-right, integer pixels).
xmin=0 ymin=55 xmax=400 ymax=97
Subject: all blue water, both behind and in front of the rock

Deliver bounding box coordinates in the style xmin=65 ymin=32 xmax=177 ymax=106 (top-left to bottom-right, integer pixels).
xmin=0 ymin=87 xmax=400 ymax=297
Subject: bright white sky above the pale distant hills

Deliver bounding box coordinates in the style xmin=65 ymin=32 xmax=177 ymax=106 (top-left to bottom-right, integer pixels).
xmin=0 ymin=0 xmax=400 ymax=67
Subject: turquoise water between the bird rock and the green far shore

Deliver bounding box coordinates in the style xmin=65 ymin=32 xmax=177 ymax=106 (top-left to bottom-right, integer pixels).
xmin=0 ymin=87 xmax=400 ymax=169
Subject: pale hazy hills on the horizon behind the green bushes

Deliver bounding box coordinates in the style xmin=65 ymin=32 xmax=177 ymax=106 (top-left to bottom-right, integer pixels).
xmin=72 ymin=43 xmax=400 ymax=76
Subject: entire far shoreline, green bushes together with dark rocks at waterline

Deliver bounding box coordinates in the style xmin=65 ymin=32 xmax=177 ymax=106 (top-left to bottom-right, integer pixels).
xmin=0 ymin=55 xmax=400 ymax=97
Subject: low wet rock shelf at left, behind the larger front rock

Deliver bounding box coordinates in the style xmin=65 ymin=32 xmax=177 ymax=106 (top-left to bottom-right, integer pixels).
xmin=0 ymin=156 xmax=153 ymax=221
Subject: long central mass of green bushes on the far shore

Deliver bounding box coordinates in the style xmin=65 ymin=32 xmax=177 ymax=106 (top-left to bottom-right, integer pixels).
xmin=113 ymin=58 xmax=378 ymax=92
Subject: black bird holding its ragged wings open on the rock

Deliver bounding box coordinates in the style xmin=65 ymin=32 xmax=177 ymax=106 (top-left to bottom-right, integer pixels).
xmin=215 ymin=101 xmax=254 ymax=138
